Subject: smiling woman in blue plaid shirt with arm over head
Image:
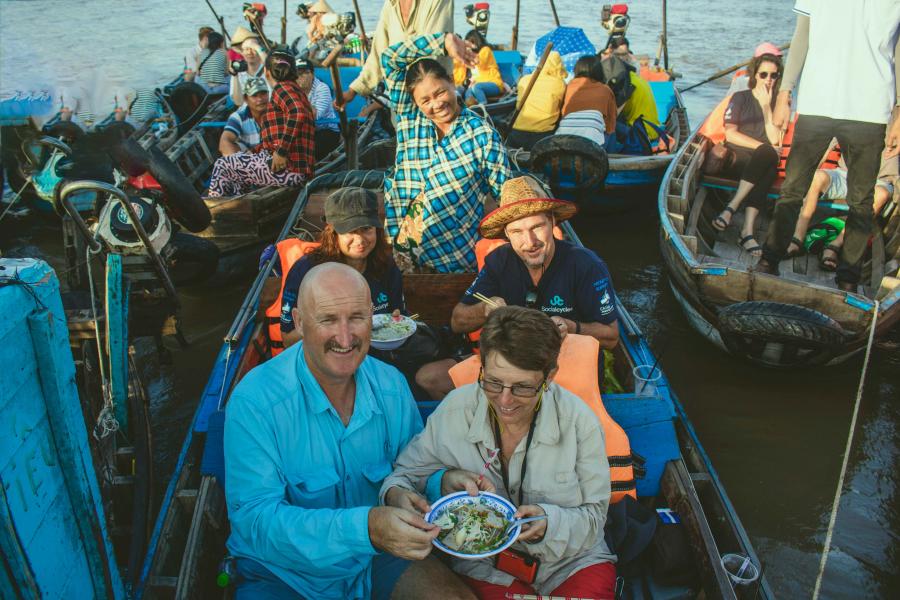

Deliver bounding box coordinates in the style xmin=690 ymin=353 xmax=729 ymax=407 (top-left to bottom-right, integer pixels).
xmin=381 ymin=34 xmax=509 ymax=273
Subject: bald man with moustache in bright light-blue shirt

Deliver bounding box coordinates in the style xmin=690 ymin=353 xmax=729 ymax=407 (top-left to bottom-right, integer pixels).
xmin=224 ymin=263 xmax=472 ymax=600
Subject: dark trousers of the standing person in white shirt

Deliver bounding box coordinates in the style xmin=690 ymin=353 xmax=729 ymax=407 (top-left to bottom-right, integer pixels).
xmin=763 ymin=115 xmax=885 ymax=284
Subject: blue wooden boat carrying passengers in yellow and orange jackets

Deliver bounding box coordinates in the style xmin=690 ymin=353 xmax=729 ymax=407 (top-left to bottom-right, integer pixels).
xmin=511 ymin=81 xmax=690 ymax=212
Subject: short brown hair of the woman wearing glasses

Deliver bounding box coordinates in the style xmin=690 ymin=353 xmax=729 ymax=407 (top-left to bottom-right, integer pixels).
xmin=478 ymin=306 xmax=562 ymax=377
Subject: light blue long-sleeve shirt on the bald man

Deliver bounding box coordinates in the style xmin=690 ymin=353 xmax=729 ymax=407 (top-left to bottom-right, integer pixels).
xmin=225 ymin=343 xmax=422 ymax=599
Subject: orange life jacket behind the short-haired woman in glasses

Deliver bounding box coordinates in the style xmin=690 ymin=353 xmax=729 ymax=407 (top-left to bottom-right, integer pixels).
xmin=450 ymin=333 xmax=644 ymax=503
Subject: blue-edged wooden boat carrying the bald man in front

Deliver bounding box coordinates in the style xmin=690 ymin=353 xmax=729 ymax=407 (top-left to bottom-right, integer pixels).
xmin=136 ymin=171 xmax=772 ymax=599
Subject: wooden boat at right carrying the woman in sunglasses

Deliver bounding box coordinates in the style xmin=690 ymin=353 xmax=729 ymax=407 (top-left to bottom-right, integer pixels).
xmin=659 ymin=130 xmax=900 ymax=367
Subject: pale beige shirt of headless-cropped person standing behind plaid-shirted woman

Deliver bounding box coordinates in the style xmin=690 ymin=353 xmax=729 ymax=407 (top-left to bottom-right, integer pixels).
xmin=350 ymin=0 xmax=453 ymax=96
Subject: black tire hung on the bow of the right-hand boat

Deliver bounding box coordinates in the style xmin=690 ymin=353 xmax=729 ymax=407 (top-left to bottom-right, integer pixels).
xmin=719 ymin=302 xmax=849 ymax=367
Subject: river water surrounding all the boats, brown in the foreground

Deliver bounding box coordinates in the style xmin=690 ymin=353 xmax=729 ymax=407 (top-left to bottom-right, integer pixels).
xmin=0 ymin=0 xmax=900 ymax=598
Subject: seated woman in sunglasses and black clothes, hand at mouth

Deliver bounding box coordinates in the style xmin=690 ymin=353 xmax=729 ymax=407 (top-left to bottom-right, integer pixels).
xmin=712 ymin=54 xmax=783 ymax=257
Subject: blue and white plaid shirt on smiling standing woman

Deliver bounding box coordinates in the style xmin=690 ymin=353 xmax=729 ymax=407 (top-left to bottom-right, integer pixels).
xmin=381 ymin=33 xmax=510 ymax=273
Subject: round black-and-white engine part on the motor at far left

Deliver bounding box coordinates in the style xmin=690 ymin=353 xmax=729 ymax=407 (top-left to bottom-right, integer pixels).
xmin=95 ymin=196 xmax=172 ymax=254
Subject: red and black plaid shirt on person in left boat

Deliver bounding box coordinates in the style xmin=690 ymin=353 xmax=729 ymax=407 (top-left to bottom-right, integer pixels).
xmin=258 ymin=81 xmax=316 ymax=179
